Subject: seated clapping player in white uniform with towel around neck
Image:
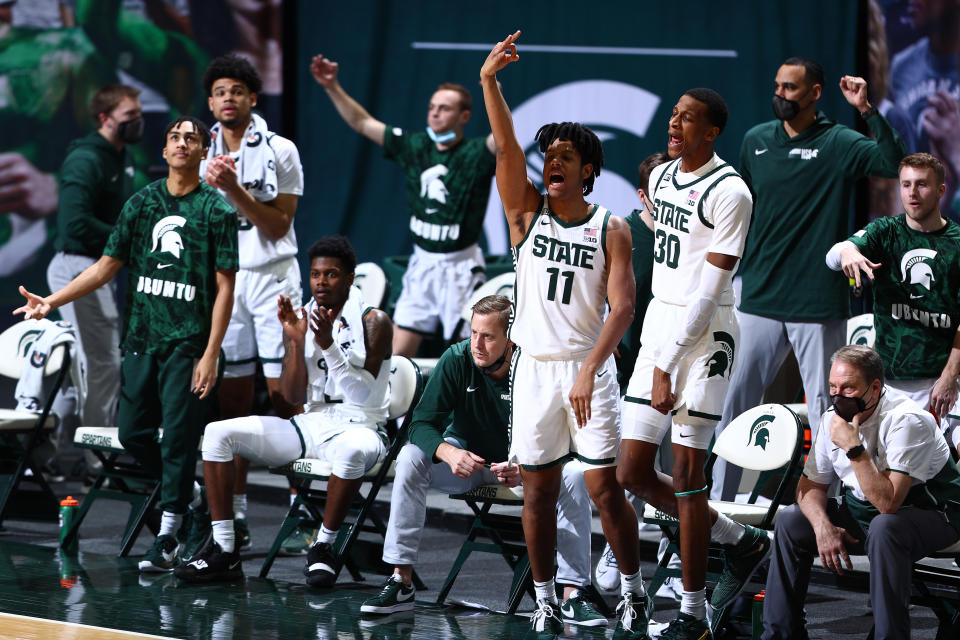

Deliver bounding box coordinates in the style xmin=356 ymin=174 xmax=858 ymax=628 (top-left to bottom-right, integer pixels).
xmin=175 ymin=236 xmax=393 ymax=587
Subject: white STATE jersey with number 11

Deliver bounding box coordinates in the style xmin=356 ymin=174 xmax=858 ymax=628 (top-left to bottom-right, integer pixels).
xmin=510 ymin=196 xmax=610 ymax=360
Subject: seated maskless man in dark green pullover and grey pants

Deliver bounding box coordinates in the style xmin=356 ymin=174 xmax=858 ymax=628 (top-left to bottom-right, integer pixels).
xmin=360 ymin=295 xmax=607 ymax=626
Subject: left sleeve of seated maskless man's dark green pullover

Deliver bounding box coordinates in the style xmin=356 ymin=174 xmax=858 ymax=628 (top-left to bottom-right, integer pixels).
xmin=409 ymin=349 xmax=464 ymax=462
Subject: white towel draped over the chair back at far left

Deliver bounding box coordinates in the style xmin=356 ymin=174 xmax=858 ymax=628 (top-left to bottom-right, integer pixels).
xmin=14 ymin=318 xmax=80 ymax=412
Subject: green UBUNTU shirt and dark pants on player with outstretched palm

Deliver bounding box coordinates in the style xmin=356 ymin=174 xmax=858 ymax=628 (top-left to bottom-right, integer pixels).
xmin=104 ymin=179 xmax=238 ymax=513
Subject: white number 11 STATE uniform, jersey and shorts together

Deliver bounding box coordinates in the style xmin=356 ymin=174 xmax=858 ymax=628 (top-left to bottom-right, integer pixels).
xmin=510 ymin=196 xmax=620 ymax=469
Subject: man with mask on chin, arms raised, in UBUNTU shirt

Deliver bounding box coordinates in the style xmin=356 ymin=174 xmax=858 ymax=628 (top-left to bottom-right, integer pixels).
xmin=310 ymin=54 xmax=496 ymax=356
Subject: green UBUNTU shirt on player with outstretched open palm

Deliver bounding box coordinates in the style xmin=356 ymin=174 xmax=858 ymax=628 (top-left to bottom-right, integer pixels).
xmin=104 ymin=178 xmax=239 ymax=357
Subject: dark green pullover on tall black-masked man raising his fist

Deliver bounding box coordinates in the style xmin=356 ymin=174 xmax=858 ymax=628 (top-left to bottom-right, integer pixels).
xmin=739 ymin=113 xmax=907 ymax=322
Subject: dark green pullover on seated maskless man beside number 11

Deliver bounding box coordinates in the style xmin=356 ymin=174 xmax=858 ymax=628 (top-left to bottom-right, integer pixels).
xmin=410 ymin=340 xmax=510 ymax=462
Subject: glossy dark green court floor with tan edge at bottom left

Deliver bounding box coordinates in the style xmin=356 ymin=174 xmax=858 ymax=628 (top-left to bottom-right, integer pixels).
xmin=0 ymin=541 xmax=548 ymax=640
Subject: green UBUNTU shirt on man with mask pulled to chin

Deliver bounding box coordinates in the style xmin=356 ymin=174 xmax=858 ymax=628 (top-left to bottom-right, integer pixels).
xmin=383 ymin=127 xmax=497 ymax=253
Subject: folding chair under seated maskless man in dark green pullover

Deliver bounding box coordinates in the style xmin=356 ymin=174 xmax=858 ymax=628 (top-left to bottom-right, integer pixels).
xmin=437 ymin=484 xmax=536 ymax=614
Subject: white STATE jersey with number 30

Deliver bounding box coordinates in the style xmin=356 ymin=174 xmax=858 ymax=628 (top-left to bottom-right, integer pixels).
xmin=650 ymin=154 xmax=753 ymax=305
